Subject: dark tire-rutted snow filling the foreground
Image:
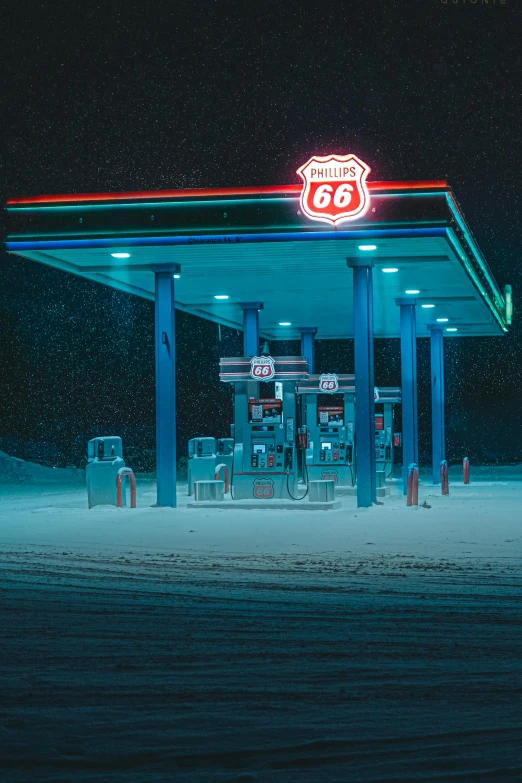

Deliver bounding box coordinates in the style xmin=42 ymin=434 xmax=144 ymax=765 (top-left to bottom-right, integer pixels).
xmin=0 ymin=550 xmax=522 ymax=783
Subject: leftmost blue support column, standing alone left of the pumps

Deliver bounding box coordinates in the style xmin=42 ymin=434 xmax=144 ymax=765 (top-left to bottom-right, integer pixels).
xmin=154 ymin=264 xmax=179 ymax=508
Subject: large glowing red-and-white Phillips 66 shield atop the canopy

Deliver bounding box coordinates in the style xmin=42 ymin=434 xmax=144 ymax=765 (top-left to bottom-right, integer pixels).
xmin=297 ymin=155 xmax=371 ymax=226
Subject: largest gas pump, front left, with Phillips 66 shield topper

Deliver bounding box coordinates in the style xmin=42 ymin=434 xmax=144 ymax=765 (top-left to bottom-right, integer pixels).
xmin=216 ymin=356 xmax=308 ymax=501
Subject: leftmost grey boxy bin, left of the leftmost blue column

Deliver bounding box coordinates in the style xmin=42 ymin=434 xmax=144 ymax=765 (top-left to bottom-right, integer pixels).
xmin=85 ymin=435 xmax=125 ymax=508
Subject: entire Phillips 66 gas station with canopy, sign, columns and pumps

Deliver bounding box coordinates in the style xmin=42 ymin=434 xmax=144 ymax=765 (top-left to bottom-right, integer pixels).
xmin=6 ymin=155 xmax=511 ymax=513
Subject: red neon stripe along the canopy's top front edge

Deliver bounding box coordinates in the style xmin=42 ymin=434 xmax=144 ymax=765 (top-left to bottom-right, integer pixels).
xmin=6 ymin=180 xmax=448 ymax=205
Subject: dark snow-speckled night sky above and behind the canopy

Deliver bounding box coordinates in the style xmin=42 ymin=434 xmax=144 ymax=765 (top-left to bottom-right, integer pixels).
xmin=0 ymin=0 xmax=522 ymax=469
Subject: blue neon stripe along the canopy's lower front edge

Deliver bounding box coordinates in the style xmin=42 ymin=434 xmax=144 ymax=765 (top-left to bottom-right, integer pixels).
xmin=6 ymin=228 xmax=446 ymax=250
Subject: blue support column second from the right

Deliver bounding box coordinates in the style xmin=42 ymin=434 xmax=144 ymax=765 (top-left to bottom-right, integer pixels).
xmin=395 ymin=299 xmax=419 ymax=494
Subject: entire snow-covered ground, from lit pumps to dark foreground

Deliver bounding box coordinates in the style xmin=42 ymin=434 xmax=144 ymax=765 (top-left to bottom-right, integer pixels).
xmin=0 ymin=468 xmax=522 ymax=783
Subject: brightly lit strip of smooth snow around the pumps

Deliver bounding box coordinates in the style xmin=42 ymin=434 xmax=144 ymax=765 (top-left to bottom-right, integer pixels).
xmin=0 ymin=468 xmax=522 ymax=558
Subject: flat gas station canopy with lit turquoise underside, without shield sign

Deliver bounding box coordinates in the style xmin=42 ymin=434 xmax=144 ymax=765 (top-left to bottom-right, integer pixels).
xmin=7 ymin=181 xmax=509 ymax=340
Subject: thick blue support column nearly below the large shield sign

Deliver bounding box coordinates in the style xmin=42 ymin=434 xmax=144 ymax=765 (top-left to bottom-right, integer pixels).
xmin=347 ymin=258 xmax=377 ymax=508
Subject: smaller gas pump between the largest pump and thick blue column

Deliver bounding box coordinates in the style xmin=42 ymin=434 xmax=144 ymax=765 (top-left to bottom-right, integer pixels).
xmin=297 ymin=375 xmax=356 ymax=486
